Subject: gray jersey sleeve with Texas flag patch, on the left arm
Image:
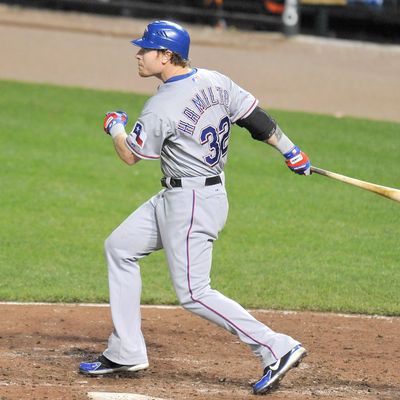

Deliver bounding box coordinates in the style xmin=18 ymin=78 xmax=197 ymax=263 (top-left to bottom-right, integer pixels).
xmin=126 ymin=107 xmax=168 ymax=160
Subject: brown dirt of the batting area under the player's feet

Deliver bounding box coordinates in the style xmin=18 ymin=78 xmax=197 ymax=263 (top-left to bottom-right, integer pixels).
xmin=0 ymin=304 xmax=400 ymax=400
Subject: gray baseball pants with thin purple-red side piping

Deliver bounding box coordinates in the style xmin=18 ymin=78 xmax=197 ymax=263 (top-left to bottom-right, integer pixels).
xmin=104 ymin=175 xmax=298 ymax=367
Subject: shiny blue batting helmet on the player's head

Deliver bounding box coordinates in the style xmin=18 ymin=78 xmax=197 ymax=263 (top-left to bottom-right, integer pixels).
xmin=131 ymin=21 xmax=190 ymax=60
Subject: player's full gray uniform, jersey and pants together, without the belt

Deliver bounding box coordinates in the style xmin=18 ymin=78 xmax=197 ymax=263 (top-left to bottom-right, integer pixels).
xmin=104 ymin=69 xmax=298 ymax=367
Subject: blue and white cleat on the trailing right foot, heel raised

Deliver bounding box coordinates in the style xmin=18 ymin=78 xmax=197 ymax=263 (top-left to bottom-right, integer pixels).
xmin=253 ymin=344 xmax=307 ymax=394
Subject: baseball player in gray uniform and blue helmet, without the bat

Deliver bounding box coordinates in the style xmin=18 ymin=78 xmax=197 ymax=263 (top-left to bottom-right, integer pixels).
xmin=79 ymin=21 xmax=310 ymax=394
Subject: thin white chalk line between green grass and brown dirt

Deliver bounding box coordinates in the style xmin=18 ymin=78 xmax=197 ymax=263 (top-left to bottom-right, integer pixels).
xmin=0 ymin=301 xmax=400 ymax=321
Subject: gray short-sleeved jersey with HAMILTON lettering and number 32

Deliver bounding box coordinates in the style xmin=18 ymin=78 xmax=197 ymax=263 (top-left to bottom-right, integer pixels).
xmin=126 ymin=69 xmax=258 ymax=177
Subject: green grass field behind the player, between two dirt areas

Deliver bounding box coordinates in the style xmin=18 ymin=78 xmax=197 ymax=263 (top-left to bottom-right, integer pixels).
xmin=0 ymin=81 xmax=400 ymax=315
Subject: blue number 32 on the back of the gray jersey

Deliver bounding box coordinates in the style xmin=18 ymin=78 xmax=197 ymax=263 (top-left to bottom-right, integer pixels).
xmin=200 ymin=116 xmax=231 ymax=167
